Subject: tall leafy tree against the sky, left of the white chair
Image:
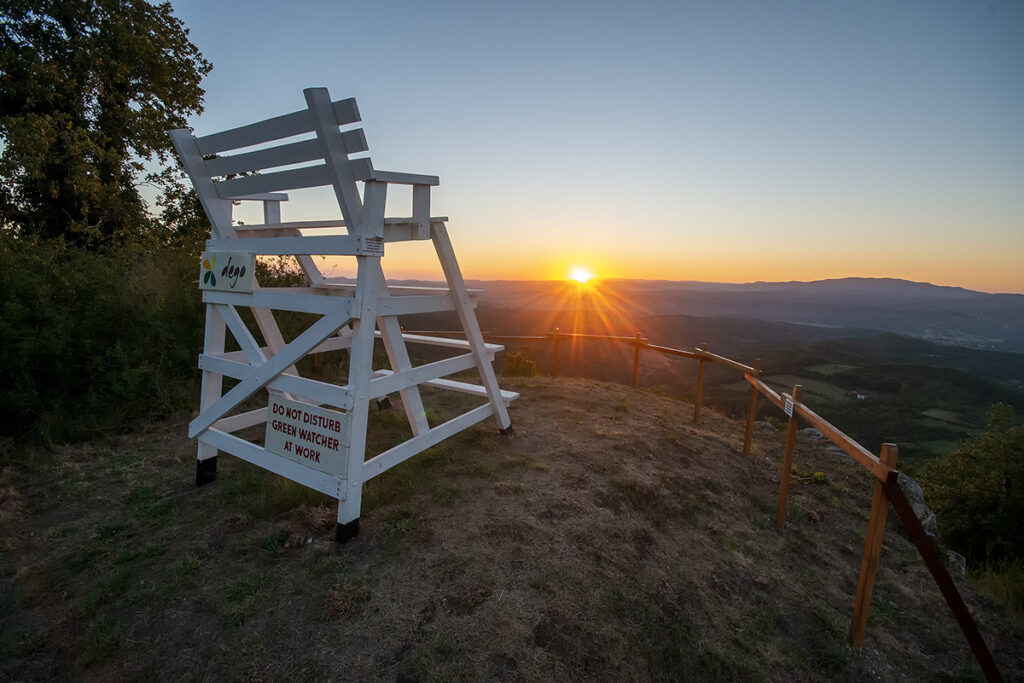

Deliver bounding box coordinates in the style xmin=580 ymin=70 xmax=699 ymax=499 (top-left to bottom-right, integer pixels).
xmin=0 ymin=0 xmax=211 ymax=248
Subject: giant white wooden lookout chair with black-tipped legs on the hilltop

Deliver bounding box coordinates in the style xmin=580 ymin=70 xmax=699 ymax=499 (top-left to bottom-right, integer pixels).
xmin=169 ymin=88 xmax=518 ymax=543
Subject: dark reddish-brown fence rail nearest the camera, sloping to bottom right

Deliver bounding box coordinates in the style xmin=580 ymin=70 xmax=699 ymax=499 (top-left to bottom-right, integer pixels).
xmin=885 ymin=479 xmax=1004 ymax=683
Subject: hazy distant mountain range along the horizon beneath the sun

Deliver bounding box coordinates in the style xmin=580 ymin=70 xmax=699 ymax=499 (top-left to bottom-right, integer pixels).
xmin=452 ymin=278 xmax=1024 ymax=352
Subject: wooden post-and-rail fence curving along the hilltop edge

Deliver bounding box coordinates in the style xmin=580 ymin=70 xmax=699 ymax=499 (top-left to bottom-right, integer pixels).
xmin=397 ymin=328 xmax=1004 ymax=682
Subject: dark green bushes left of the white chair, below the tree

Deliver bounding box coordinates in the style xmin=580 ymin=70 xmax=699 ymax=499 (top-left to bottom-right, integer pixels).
xmin=0 ymin=233 xmax=203 ymax=440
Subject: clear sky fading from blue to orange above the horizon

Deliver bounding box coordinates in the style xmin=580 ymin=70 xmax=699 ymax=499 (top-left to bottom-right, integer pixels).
xmin=172 ymin=0 xmax=1024 ymax=292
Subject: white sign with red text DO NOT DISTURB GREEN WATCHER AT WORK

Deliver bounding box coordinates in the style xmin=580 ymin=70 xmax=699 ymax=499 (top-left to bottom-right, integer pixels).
xmin=263 ymin=392 xmax=348 ymax=477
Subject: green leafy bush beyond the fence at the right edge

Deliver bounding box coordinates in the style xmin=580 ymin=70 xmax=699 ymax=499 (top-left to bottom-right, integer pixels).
xmin=921 ymin=403 xmax=1024 ymax=562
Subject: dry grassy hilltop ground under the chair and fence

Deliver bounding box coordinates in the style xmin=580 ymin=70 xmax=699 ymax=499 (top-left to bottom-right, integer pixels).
xmin=0 ymin=379 xmax=1024 ymax=681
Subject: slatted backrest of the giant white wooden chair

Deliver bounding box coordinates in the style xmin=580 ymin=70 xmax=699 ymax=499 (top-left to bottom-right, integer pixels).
xmin=169 ymin=88 xmax=373 ymax=238
